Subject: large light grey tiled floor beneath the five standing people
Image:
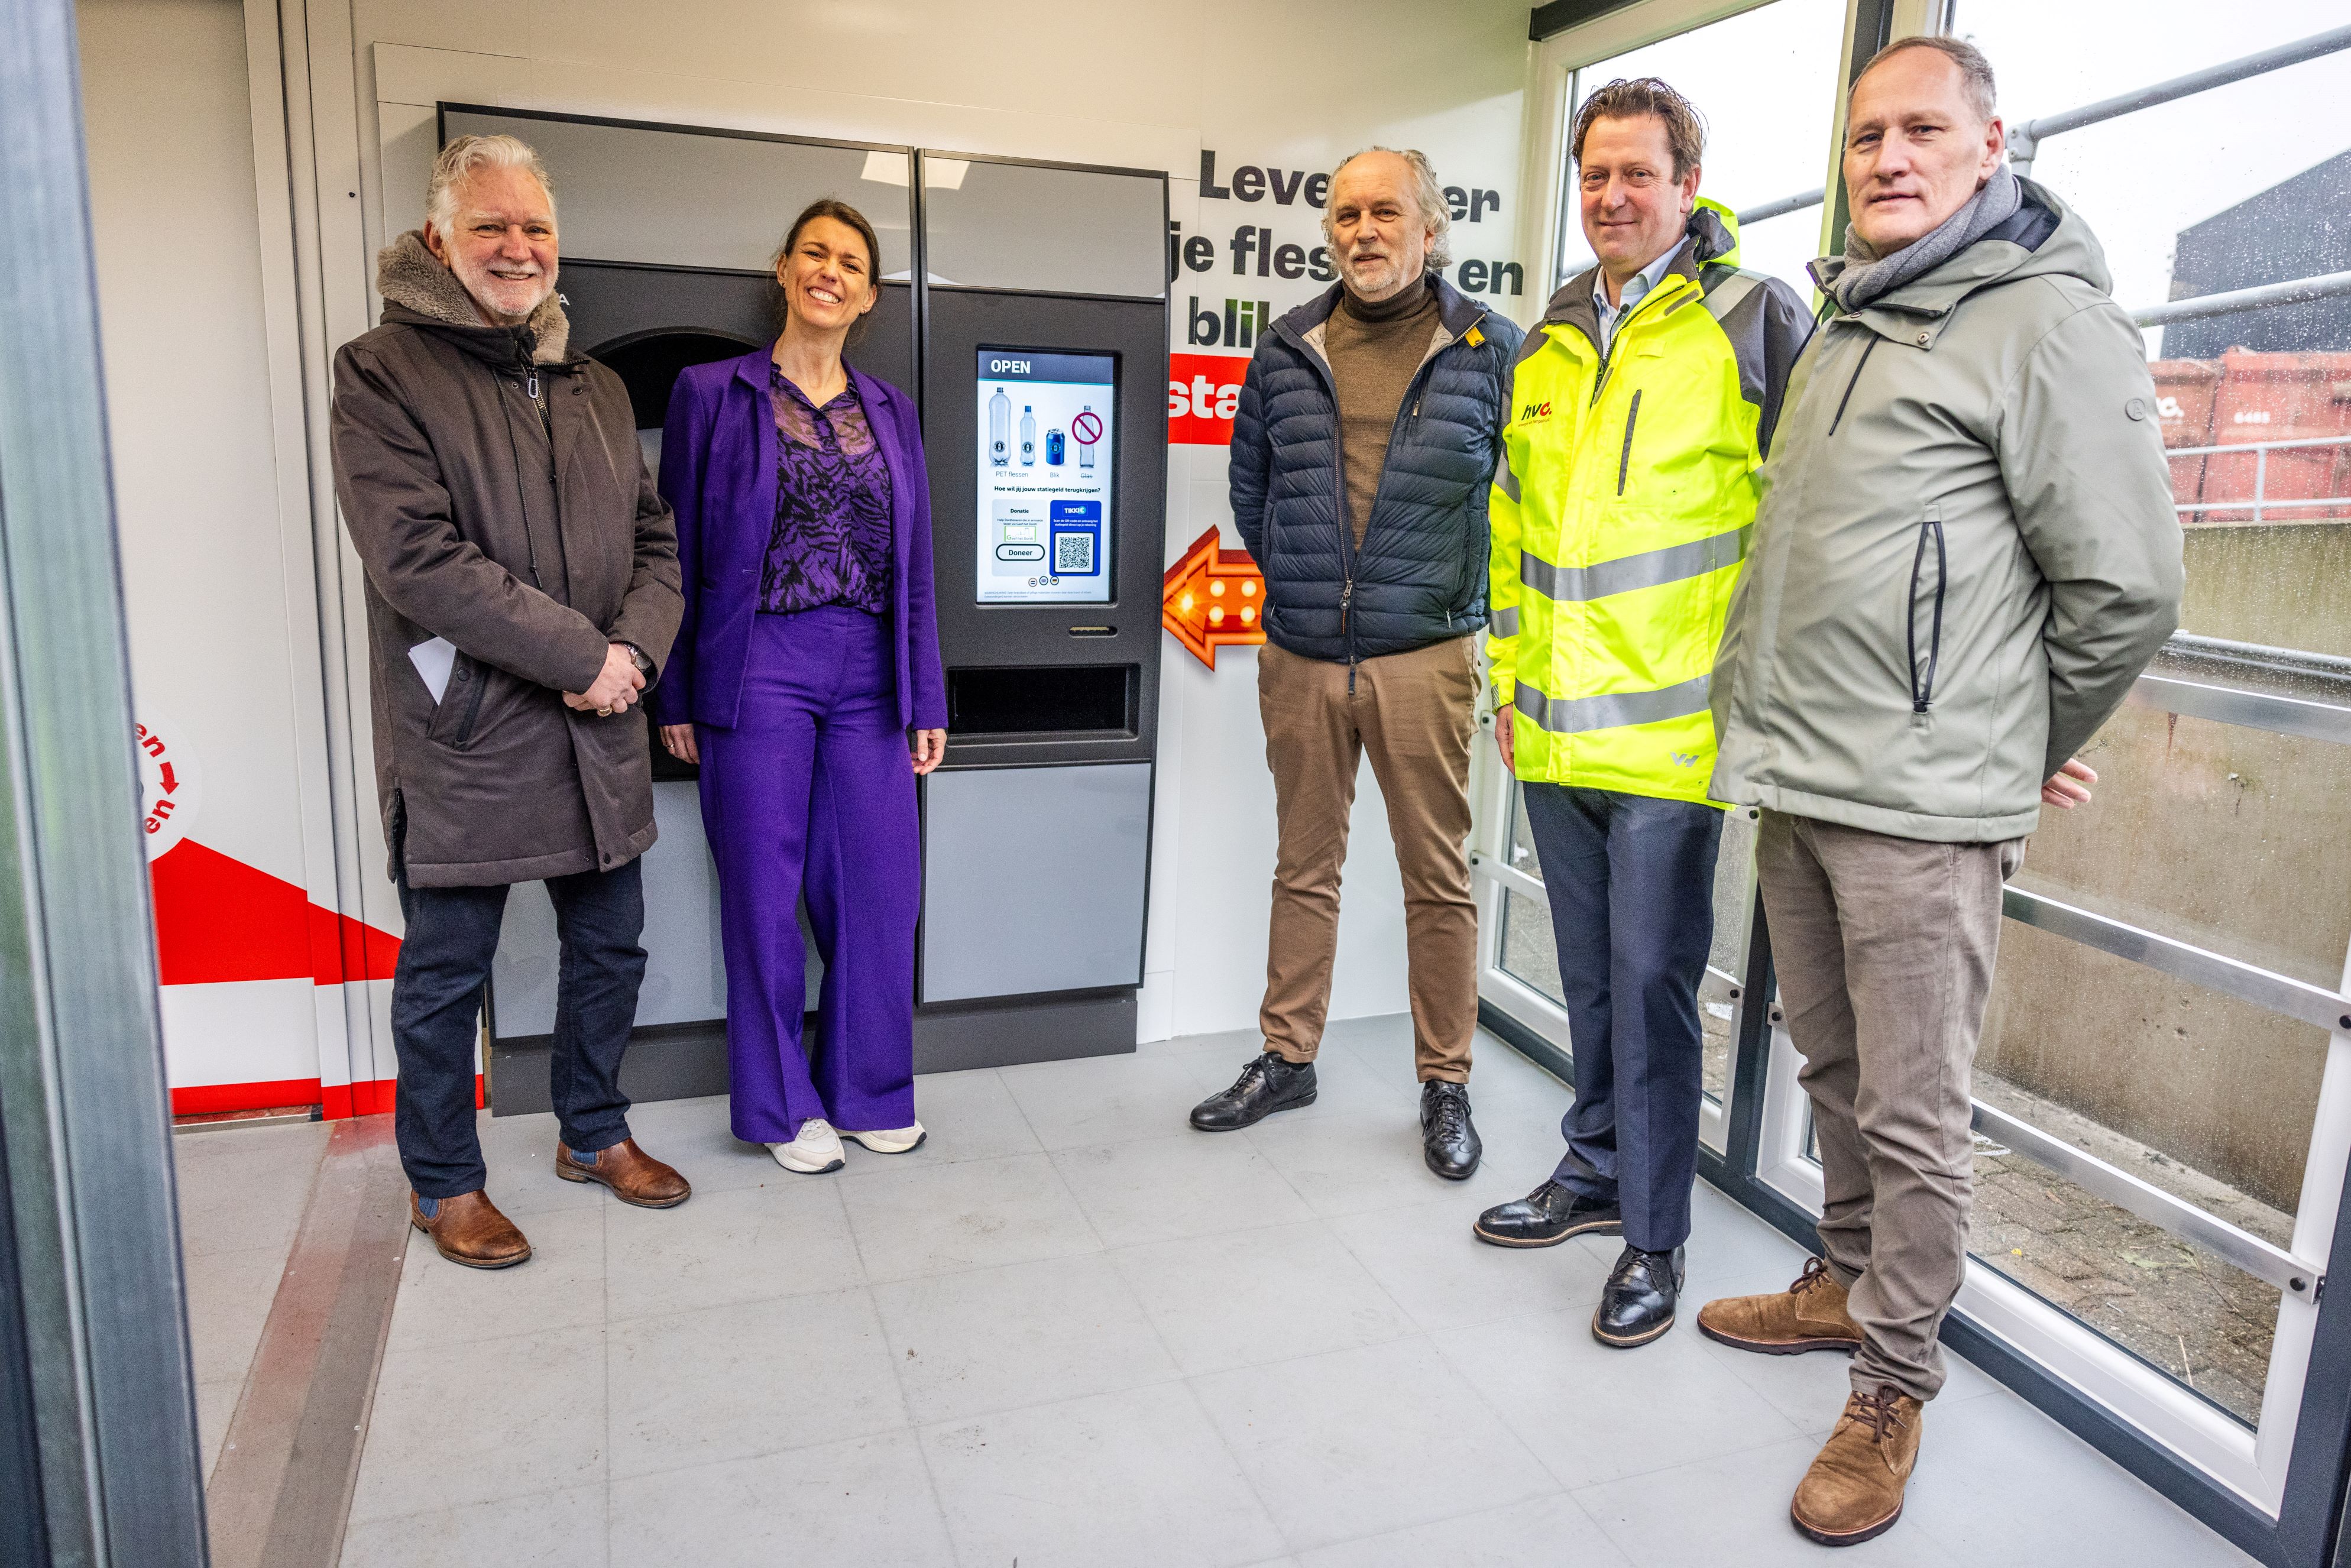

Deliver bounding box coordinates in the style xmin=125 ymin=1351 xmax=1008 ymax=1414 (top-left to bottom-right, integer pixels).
xmin=303 ymin=1018 xmax=2248 ymax=1568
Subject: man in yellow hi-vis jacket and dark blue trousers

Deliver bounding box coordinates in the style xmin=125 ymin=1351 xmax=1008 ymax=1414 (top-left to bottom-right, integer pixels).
xmin=1476 ymin=77 xmax=1811 ymax=1347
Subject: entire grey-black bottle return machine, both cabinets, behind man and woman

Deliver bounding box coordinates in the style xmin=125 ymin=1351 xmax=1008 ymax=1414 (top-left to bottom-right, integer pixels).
xmin=440 ymin=103 xmax=1166 ymax=1115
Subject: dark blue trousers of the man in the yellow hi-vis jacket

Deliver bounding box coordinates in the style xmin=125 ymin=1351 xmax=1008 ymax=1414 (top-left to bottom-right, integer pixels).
xmin=1518 ymin=783 xmax=1723 ymax=1253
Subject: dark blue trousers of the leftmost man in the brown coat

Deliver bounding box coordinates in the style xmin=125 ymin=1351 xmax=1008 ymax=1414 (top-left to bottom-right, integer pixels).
xmin=393 ymin=860 xmax=644 ymax=1199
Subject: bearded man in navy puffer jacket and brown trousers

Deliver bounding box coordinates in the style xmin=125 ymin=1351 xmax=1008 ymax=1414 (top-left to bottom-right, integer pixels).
xmin=1192 ymin=148 xmax=1521 ymax=1180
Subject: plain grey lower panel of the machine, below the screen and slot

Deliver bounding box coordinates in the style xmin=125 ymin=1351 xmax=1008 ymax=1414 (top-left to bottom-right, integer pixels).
xmin=917 ymin=762 xmax=1152 ymax=1004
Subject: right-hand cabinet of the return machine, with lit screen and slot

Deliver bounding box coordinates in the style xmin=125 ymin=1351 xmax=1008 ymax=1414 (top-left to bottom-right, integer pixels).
xmin=915 ymin=153 xmax=1168 ymax=1067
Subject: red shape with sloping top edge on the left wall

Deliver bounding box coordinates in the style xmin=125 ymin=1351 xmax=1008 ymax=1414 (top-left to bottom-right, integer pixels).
xmin=148 ymin=839 xmax=400 ymax=987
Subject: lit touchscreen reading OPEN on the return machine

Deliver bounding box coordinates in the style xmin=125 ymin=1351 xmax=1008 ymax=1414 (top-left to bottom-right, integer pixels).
xmin=978 ymin=348 xmax=1117 ymax=604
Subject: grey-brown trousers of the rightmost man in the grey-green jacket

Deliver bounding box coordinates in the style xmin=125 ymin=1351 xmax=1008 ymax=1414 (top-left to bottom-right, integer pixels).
xmin=1756 ymin=811 xmax=2024 ymax=1401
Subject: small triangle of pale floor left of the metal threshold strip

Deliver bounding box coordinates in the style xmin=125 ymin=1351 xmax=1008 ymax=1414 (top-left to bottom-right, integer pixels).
xmin=171 ymin=1122 xmax=332 ymax=1476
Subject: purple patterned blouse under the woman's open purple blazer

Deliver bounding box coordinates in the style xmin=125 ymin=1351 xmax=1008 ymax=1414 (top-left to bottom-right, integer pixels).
xmin=759 ymin=367 xmax=891 ymax=616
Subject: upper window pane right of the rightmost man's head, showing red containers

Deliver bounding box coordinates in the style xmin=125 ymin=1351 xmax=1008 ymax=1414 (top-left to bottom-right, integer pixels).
xmin=1956 ymin=0 xmax=2351 ymax=656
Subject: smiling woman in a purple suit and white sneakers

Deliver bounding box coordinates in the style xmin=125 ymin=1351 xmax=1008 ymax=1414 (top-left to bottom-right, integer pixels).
xmin=651 ymin=200 xmax=947 ymax=1173
